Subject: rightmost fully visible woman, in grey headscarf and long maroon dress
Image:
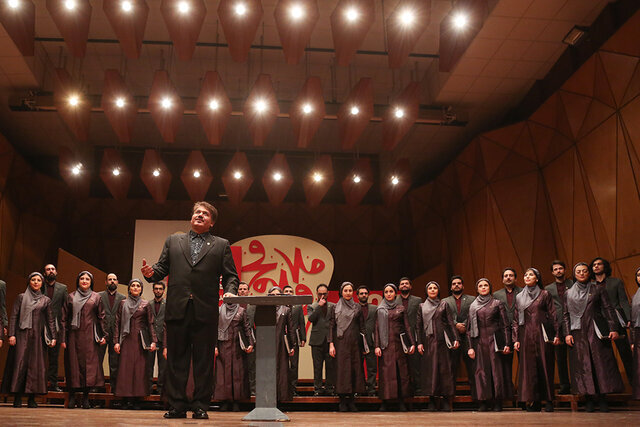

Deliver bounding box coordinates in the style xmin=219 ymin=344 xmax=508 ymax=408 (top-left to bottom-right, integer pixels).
xmin=563 ymin=262 xmax=624 ymax=412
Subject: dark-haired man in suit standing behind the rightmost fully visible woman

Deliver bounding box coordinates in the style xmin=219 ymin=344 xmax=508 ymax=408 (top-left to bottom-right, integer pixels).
xmin=591 ymin=257 xmax=633 ymax=383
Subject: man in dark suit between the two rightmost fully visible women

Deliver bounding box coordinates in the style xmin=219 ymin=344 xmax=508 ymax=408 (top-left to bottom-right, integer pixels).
xmin=544 ymin=259 xmax=573 ymax=394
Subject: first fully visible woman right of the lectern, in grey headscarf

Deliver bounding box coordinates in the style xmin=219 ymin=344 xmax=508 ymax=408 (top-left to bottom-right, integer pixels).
xmin=327 ymin=282 xmax=366 ymax=412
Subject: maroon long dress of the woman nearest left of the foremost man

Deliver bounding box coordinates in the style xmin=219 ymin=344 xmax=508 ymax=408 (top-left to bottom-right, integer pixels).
xmin=113 ymin=299 xmax=156 ymax=397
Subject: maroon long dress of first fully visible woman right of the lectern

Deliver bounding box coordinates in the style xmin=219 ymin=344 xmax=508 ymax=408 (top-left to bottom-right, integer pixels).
xmin=327 ymin=306 xmax=366 ymax=394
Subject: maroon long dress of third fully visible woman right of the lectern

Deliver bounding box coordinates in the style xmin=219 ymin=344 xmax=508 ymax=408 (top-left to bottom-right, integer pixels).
xmin=416 ymin=301 xmax=460 ymax=397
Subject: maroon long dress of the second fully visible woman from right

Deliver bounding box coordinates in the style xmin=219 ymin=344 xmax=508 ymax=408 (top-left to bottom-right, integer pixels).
xmin=512 ymin=290 xmax=560 ymax=402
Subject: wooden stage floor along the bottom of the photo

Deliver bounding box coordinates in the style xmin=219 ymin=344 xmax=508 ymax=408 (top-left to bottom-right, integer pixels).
xmin=0 ymin=405 xmax=640 ymax=427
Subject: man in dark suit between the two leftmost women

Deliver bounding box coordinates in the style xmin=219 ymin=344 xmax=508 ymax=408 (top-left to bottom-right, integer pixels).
xmin=42 ymin=264 xmax=67 ymax=392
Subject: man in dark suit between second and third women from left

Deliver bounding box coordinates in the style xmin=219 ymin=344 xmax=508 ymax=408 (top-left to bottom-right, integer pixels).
xmin=98 ymin=273 xmax=126 ymax=393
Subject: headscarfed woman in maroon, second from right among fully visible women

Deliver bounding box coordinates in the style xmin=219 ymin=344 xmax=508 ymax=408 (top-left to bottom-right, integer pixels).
xmin=512 ymin=268 xmax=560 ymax=412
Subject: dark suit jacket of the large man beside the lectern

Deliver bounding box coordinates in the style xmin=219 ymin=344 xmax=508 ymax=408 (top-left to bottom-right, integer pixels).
xmin=145 ymin=233 xmax=238 ymax=324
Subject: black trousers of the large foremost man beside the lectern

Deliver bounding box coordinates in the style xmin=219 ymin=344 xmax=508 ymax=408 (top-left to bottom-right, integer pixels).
xmin=165 ymin=300 xmax=218 ymax=411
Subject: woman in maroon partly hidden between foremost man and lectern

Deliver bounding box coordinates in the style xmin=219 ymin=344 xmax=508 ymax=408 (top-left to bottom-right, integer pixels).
xmin=213 ymin=296 xmax=255 ymax=412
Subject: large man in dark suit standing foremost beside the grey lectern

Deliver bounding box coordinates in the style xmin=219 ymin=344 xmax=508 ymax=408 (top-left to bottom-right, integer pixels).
xmin=141 ymin=202 xmax=238 ymax=419
